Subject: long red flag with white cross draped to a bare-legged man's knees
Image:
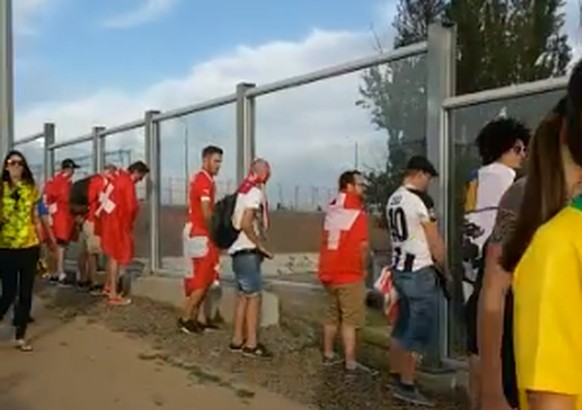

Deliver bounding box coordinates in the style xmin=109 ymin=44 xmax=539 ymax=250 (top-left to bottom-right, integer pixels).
xmin=96 ymin=171 xmax=139 ymax=265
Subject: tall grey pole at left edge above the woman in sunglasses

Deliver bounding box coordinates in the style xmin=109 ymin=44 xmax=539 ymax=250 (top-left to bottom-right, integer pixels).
xmin=0 ymin=0 xmax=14 ymax=158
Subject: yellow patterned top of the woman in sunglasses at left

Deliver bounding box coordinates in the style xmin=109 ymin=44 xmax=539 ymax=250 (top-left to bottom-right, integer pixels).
xmin=0 ymin=182 xmax=40 ymax=249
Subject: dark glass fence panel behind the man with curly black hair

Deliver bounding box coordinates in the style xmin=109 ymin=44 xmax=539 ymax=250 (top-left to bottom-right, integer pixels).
xmin=448 ymin=90 xmax=564 ymax=354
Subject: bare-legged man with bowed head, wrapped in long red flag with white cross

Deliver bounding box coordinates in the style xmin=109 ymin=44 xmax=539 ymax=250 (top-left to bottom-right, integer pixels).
xmin=96 ymin=161 xmax=149 ymax=306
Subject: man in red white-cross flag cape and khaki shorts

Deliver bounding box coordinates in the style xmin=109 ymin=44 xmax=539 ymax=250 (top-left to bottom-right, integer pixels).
xmin=319 ymin=171 xmax=370 ymax=374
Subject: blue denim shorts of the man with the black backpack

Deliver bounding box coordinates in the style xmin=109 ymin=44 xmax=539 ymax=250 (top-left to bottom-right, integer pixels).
xmin=232 ymin=250 xmax=263 ymax=296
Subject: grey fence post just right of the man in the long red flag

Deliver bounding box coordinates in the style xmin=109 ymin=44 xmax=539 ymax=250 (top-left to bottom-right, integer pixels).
xmin=144 ymin=110 xmax=161 ymax=273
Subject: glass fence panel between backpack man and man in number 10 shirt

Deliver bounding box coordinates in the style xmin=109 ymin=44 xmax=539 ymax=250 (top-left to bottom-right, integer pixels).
xmin=256 ymin=55 xmax=426 ymax=271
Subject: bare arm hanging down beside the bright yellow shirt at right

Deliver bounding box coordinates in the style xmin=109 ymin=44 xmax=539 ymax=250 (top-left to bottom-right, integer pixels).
xmin=477 ymin=244 xmax=511 ymax=395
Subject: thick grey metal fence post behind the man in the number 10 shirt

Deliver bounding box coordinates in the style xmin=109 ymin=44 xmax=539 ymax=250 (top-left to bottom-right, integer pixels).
xmin=424 ymin=22 xmax=456 ymax=372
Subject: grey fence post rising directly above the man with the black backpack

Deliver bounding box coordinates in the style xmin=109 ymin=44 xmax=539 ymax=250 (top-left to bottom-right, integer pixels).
xmin=236 ymin=83 xmax=255 ymax=184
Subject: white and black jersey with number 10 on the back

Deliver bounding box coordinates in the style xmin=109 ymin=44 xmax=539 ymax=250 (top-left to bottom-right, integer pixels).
xmin=386 ymin=186 xmax=435 ymax=272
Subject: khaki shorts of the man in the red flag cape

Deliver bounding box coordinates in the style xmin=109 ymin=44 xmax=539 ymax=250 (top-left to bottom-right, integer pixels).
xmin=325 ymin=281 xmax=366 ymax=328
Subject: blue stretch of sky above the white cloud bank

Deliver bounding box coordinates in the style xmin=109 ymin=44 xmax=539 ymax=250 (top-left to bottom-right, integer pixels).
xmin=15 ymin=0 xmax=388 ymax=108
